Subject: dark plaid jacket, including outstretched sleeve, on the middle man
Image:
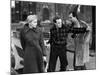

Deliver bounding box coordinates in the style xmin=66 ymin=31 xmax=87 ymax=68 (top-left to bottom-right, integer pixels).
xmin=48 ymin=25 xmax=86 ymax=46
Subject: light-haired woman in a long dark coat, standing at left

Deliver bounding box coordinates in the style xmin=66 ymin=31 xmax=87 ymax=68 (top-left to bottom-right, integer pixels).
xmin=20 ymin=15 xmax=46 ymax=74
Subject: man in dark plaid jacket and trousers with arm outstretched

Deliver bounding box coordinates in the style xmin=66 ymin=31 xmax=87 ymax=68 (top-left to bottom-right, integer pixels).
xmin=48 ymin=17 xmax=86 ymax=72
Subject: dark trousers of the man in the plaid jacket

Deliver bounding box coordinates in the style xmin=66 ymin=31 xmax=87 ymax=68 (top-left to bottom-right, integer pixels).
xmin=48 ymin=45 xmax=68 ymax=72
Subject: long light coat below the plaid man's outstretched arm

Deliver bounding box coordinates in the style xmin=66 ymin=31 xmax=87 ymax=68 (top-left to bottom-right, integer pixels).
xmin=74 ymin=26 xmax=91 ymax=66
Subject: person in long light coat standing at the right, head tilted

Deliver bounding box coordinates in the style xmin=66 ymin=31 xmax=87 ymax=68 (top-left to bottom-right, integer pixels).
xmin=69 ymin=12 xmax=91 ymax=70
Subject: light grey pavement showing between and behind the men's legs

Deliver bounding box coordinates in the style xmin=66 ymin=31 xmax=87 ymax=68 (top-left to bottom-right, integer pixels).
xmin=47 ymin=49 xmax=96 ymax=71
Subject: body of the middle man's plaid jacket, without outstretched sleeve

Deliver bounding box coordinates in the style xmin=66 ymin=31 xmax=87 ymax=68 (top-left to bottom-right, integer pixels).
xmin=49 ymin=25 xmax=67 ymax=45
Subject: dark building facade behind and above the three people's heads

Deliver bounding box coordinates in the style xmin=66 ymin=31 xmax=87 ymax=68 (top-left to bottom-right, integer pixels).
xmin=11 ymin=1 xmax=92 ymax=23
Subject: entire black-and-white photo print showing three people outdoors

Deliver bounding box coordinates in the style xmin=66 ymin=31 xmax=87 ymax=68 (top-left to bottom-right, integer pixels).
xmin=10 ymin=0 xmax=96 ymax=75
